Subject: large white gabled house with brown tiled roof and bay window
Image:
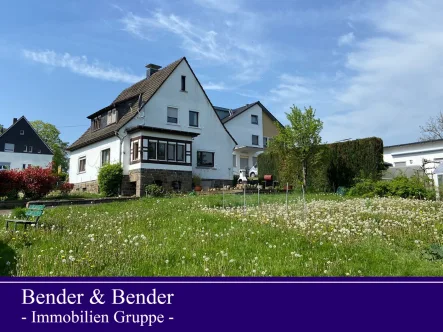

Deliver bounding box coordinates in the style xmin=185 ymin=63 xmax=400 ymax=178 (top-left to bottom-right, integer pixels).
xmin=68 ymin=58 xmax=236 ymax=196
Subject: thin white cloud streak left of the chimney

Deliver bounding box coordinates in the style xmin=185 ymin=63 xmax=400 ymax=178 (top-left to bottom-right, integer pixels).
xmin=22 ymin=49 xmax=143 ymax=83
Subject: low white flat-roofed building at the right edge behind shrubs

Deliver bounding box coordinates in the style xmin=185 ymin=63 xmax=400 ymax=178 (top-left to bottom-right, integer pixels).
xmin=383 ymin=139 xmax=443 ymax=184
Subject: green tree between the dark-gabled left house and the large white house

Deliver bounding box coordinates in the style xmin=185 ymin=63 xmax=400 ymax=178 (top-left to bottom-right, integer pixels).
xmin=31 ymin=120 xmax=69 ymax=172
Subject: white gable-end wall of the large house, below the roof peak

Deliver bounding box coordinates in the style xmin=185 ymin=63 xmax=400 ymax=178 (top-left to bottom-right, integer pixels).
xmin=131 ymin=61 xmax=235 ymax=180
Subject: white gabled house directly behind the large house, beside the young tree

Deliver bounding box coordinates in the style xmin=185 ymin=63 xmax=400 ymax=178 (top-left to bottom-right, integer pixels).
xmin=215 ymin=101 xmax=282 ymax=175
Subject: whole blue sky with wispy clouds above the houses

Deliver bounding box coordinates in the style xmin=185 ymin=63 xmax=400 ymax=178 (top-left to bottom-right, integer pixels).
xmin=0 ymin=0 xmax=443 ymax=145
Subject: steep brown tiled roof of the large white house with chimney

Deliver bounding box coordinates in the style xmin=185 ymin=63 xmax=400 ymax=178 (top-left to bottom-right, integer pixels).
xmin=67 ymin=57 xmax=237 ymax=151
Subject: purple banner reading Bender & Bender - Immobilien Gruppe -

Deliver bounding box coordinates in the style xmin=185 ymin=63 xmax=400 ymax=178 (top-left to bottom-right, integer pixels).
xmin=0 ymin=278 xmax=443 ymax=331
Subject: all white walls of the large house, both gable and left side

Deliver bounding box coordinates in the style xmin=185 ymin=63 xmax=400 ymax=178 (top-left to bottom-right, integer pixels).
xmin=69 ymin=61 xmax=235 ymax=184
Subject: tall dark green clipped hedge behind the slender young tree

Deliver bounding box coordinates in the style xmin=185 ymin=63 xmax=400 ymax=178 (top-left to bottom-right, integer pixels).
xmin=258 ymin=137 xmax=384 ymax=192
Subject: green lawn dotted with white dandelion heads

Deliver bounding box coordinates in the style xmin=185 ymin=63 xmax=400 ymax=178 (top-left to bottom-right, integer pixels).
xmin=0 ymin=194 xmax=443 ymax=276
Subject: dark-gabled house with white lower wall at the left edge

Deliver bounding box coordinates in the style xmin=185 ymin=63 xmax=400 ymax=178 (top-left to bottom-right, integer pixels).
xmin=0 ymin=116 xmax=53 ymax=170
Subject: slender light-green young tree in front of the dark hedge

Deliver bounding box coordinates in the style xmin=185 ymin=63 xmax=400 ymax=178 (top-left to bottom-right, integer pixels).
xmin=271 ymin=105 xmax=323 ymax=189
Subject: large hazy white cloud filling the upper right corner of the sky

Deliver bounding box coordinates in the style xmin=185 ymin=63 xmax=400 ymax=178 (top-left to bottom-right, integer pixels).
xmin=324 ymin=0 xmax=443 ymax=144
